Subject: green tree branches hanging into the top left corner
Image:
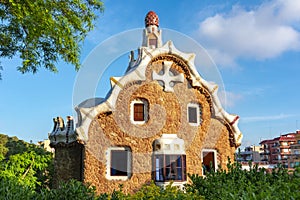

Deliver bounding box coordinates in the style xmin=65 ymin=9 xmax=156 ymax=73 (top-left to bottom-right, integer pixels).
xmin=0 ymin=0 xmax=103 ymax=77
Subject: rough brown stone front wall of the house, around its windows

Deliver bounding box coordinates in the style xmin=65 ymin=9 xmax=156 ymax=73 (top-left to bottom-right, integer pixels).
xmin=84 ymin=56 xmax=235 ymax=193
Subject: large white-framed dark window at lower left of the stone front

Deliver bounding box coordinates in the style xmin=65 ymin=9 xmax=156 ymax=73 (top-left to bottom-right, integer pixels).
xmin=106 ymin=147 xmax=131 ymax=180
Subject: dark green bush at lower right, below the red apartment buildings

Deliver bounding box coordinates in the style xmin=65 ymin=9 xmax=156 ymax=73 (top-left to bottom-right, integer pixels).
xmin=186 ymin=161 xmax=300 ymax=200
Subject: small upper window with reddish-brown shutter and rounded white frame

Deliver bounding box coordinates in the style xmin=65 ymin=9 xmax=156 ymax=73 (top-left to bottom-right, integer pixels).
xmin=131 ymin=99 xmax=148 ymax=124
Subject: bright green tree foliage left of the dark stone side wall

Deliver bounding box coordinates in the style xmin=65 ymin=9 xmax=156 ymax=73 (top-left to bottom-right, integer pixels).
xmin=0 ymin=134 xmax=53 ymax=190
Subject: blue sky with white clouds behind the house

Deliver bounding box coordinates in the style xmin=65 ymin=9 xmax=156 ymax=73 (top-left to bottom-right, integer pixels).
xmin=0 ymin=0 xmax=300 ymax=146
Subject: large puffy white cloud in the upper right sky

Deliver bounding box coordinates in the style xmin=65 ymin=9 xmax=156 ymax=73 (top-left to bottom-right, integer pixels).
xmin=197 ymin=0 xmax=300 ymax=65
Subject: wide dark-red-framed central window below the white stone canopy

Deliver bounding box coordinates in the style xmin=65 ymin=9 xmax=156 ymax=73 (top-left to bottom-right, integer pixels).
xmin=154 ymin=155 xmax=186 ymax=182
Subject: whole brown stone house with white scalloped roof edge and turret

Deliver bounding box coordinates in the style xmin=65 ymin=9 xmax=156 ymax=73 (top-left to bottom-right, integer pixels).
xmin=50 ymin=12 xmax=242 ymax=193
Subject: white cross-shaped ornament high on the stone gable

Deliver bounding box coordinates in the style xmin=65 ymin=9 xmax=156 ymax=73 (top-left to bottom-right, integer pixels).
xmin=152 ymin=61 xmax=184 ymax=92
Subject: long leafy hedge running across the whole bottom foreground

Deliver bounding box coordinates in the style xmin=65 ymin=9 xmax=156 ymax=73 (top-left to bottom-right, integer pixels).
xmin=0 ymin=163 xmax=300 ymax=200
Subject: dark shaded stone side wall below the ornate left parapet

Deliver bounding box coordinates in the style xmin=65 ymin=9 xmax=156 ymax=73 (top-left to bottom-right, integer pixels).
xmin=53 ymin=142 xmax=83 ymax=187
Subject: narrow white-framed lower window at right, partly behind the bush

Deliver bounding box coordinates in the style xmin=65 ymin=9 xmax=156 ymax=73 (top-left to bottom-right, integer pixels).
xmin=202 ymin=149 xmax=217 ymax=175
